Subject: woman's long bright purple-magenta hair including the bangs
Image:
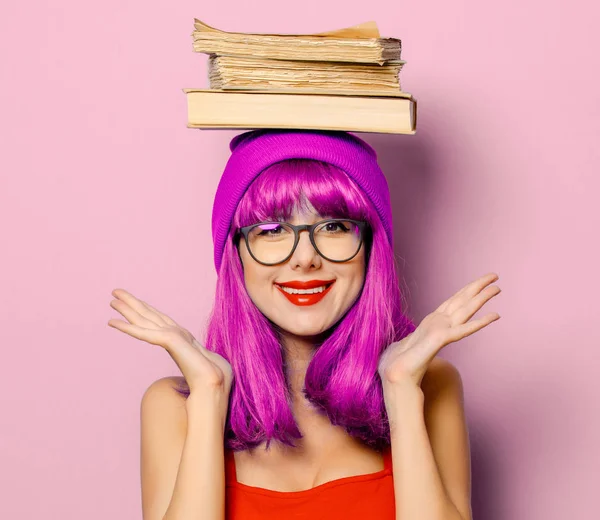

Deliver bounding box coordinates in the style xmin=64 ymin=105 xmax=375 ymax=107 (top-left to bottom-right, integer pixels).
xmin=179 ymin=159 xmax=415 ymax=450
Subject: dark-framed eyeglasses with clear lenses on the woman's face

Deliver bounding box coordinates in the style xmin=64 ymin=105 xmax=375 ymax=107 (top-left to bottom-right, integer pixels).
xmin=236 ymin=219 xmax=368 ymax=265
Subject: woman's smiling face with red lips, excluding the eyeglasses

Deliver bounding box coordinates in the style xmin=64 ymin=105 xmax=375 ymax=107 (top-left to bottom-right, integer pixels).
xmin=239 ymin=205 xmax=365 ymax=336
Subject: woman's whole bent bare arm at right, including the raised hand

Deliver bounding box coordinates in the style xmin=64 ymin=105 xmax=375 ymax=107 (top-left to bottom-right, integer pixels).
xmin=378 ymin=273 xmax=500 ymax=520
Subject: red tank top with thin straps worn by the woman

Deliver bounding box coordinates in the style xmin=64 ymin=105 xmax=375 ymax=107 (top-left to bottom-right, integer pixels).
xmin=225 ymin=447 xmax=396 ymax=520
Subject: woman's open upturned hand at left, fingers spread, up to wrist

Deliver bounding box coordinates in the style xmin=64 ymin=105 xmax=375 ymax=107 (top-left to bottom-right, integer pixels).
xmin=108 ymin=289 xmax=232 ymax=396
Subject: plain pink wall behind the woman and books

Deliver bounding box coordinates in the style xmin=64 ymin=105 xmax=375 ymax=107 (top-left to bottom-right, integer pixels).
xmin=0 ymin=0 xmax=600 ymax=520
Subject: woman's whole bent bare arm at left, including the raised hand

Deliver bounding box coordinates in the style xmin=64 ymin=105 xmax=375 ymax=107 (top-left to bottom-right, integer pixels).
xmin=108 ymin=289 xmax=233 ymax=520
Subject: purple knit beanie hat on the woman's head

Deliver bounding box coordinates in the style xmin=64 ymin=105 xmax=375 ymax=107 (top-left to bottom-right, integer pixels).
xmin=212 ymin=129 xmax=394 ymax=273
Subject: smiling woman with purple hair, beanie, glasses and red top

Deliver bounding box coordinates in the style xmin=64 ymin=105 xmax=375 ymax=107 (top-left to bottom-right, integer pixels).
xmin=108 ymin=130 xmax=500 ymax=520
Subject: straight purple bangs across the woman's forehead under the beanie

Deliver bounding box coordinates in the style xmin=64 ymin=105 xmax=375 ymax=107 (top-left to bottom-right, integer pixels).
xmin=232 ymin=159 xmax=371 ymax=228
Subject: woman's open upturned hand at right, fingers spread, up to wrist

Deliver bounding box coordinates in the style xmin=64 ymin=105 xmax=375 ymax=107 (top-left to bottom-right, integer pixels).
xmin=377 ymin=273 xmax=500 ymax=387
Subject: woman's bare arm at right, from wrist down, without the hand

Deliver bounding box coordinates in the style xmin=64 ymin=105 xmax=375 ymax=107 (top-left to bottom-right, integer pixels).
xmin=384 ymin=358 xmax=472 ymax=520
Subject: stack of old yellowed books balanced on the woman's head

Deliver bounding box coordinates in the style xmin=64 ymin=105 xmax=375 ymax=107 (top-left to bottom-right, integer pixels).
xmin=183 ymin=19 xmax=417 ymax=134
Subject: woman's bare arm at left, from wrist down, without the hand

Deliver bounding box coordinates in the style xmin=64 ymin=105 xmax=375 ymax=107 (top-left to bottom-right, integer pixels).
xmin=141 ymin=378 xmax=228 ymax=520
